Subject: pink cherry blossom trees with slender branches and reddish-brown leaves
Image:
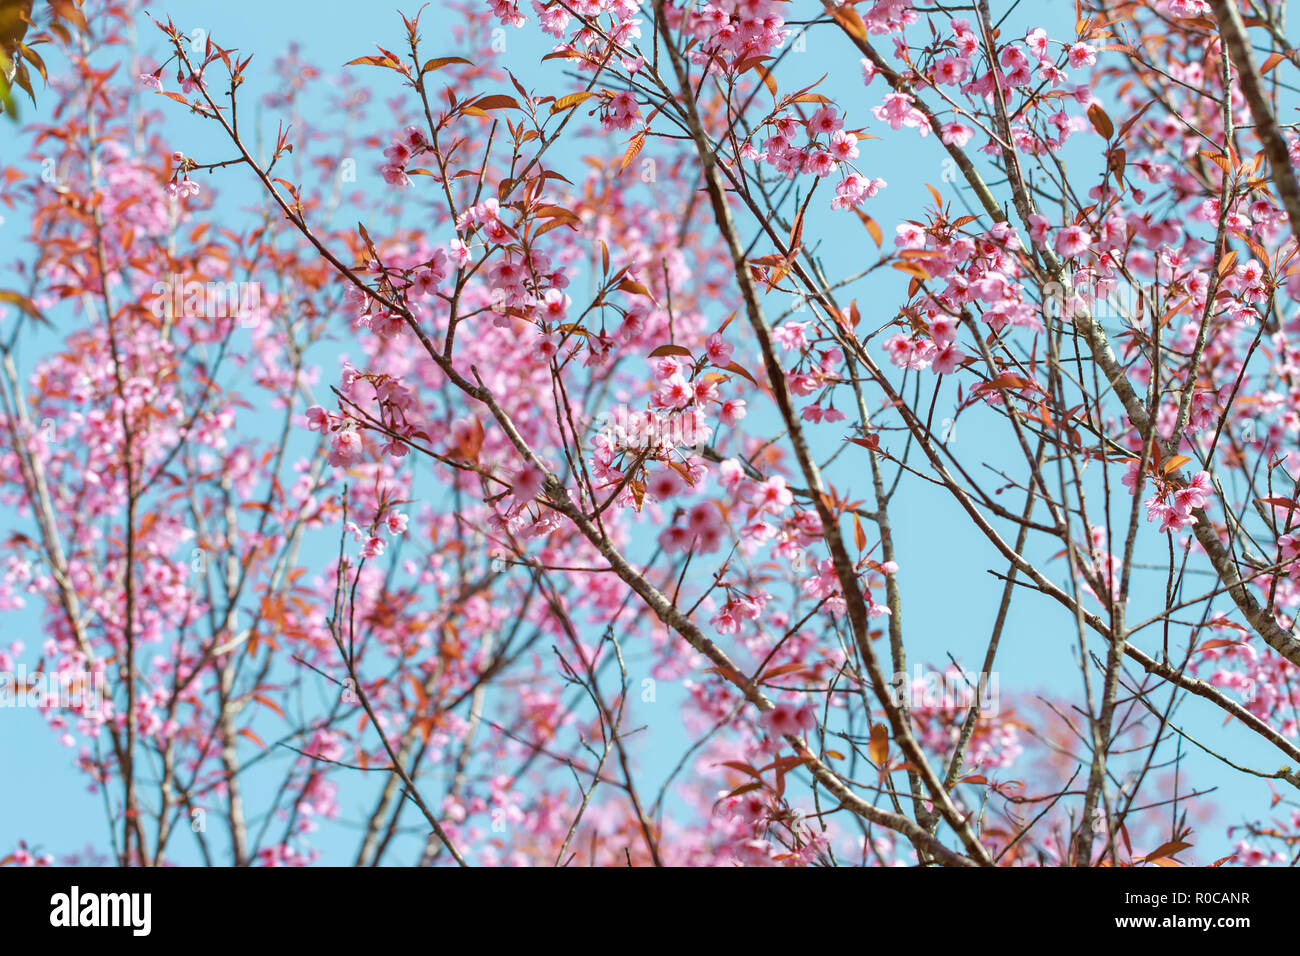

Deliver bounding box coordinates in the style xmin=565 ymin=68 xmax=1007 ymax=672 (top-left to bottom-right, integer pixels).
xmin=0 ymin=0 xmax=1300 ymax=866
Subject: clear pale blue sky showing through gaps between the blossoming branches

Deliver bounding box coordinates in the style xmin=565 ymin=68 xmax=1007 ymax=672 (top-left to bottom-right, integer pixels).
xmin=0 ymin=0 xmax=1278 ymax=862
